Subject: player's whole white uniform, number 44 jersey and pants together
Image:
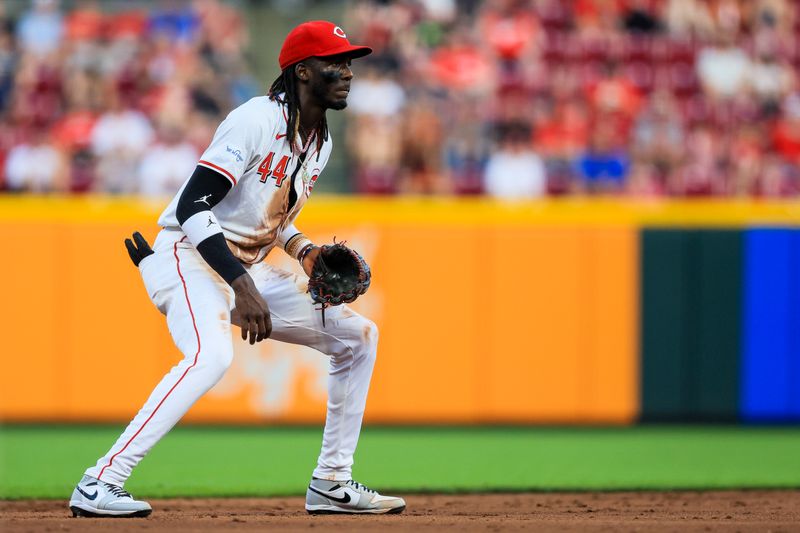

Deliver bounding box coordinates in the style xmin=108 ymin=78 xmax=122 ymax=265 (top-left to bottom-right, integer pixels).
xmin=86 ymin=97 xmax=378 ymax=486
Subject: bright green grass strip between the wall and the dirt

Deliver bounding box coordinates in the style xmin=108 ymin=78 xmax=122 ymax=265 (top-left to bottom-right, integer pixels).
xmin=0 ymin=426 xmax=800 ymax=499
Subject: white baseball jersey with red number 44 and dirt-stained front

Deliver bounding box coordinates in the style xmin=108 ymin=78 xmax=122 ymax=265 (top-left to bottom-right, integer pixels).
xmin=158 ymin=96 xmax=333 ymax=264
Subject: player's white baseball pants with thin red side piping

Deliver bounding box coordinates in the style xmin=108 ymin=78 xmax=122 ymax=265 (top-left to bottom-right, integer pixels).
xmin=86 ymin=230 xmax=378 ymax=486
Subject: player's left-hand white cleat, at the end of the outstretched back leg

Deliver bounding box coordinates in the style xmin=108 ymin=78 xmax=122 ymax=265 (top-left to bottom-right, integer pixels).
xmin=69 ymin=476 xmax=153 ymax=518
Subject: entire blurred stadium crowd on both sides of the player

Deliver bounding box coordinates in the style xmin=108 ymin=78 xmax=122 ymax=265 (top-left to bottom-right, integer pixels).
xmin=0 ymin=0 xmax=800 ymax=198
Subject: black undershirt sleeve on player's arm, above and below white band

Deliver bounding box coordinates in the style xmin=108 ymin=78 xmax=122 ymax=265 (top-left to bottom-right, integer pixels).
xmin=175 ymin=165 xmax=246 ymax=285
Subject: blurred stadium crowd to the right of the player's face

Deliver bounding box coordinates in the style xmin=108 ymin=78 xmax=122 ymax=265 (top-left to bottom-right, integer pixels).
xmin=346 ymin=0 xmax=800 ymax=198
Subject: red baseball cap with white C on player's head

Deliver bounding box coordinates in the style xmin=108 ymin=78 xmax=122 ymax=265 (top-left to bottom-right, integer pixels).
xmin=278 ymin=20 xmax=372 ymax=70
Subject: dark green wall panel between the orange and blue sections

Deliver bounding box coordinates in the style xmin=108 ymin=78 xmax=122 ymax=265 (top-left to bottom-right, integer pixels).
xmin=640 ymin=228 xmax=743 ymax=420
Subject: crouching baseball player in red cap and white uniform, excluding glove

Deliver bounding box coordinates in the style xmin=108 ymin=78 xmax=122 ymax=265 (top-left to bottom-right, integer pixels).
xmin=69 ymin=21 xmax=405 ymax=517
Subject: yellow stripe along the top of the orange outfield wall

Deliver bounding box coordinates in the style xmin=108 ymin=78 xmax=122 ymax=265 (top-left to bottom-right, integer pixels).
xmin=0 ymin=195 xmax=800 ymax=226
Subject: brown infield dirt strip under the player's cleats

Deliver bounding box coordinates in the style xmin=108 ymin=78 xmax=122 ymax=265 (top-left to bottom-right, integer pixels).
xmin=0 ymin=490 xmax=800 ymax=533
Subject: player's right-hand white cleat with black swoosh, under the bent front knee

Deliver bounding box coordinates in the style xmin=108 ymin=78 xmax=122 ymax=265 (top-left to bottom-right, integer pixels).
xmin=306 ymin=478 xmax=406 ymax=514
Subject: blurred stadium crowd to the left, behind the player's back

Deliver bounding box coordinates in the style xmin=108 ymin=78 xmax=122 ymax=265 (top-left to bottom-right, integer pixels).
xmin=0 ymin=0 xmax=261 ymax=195
